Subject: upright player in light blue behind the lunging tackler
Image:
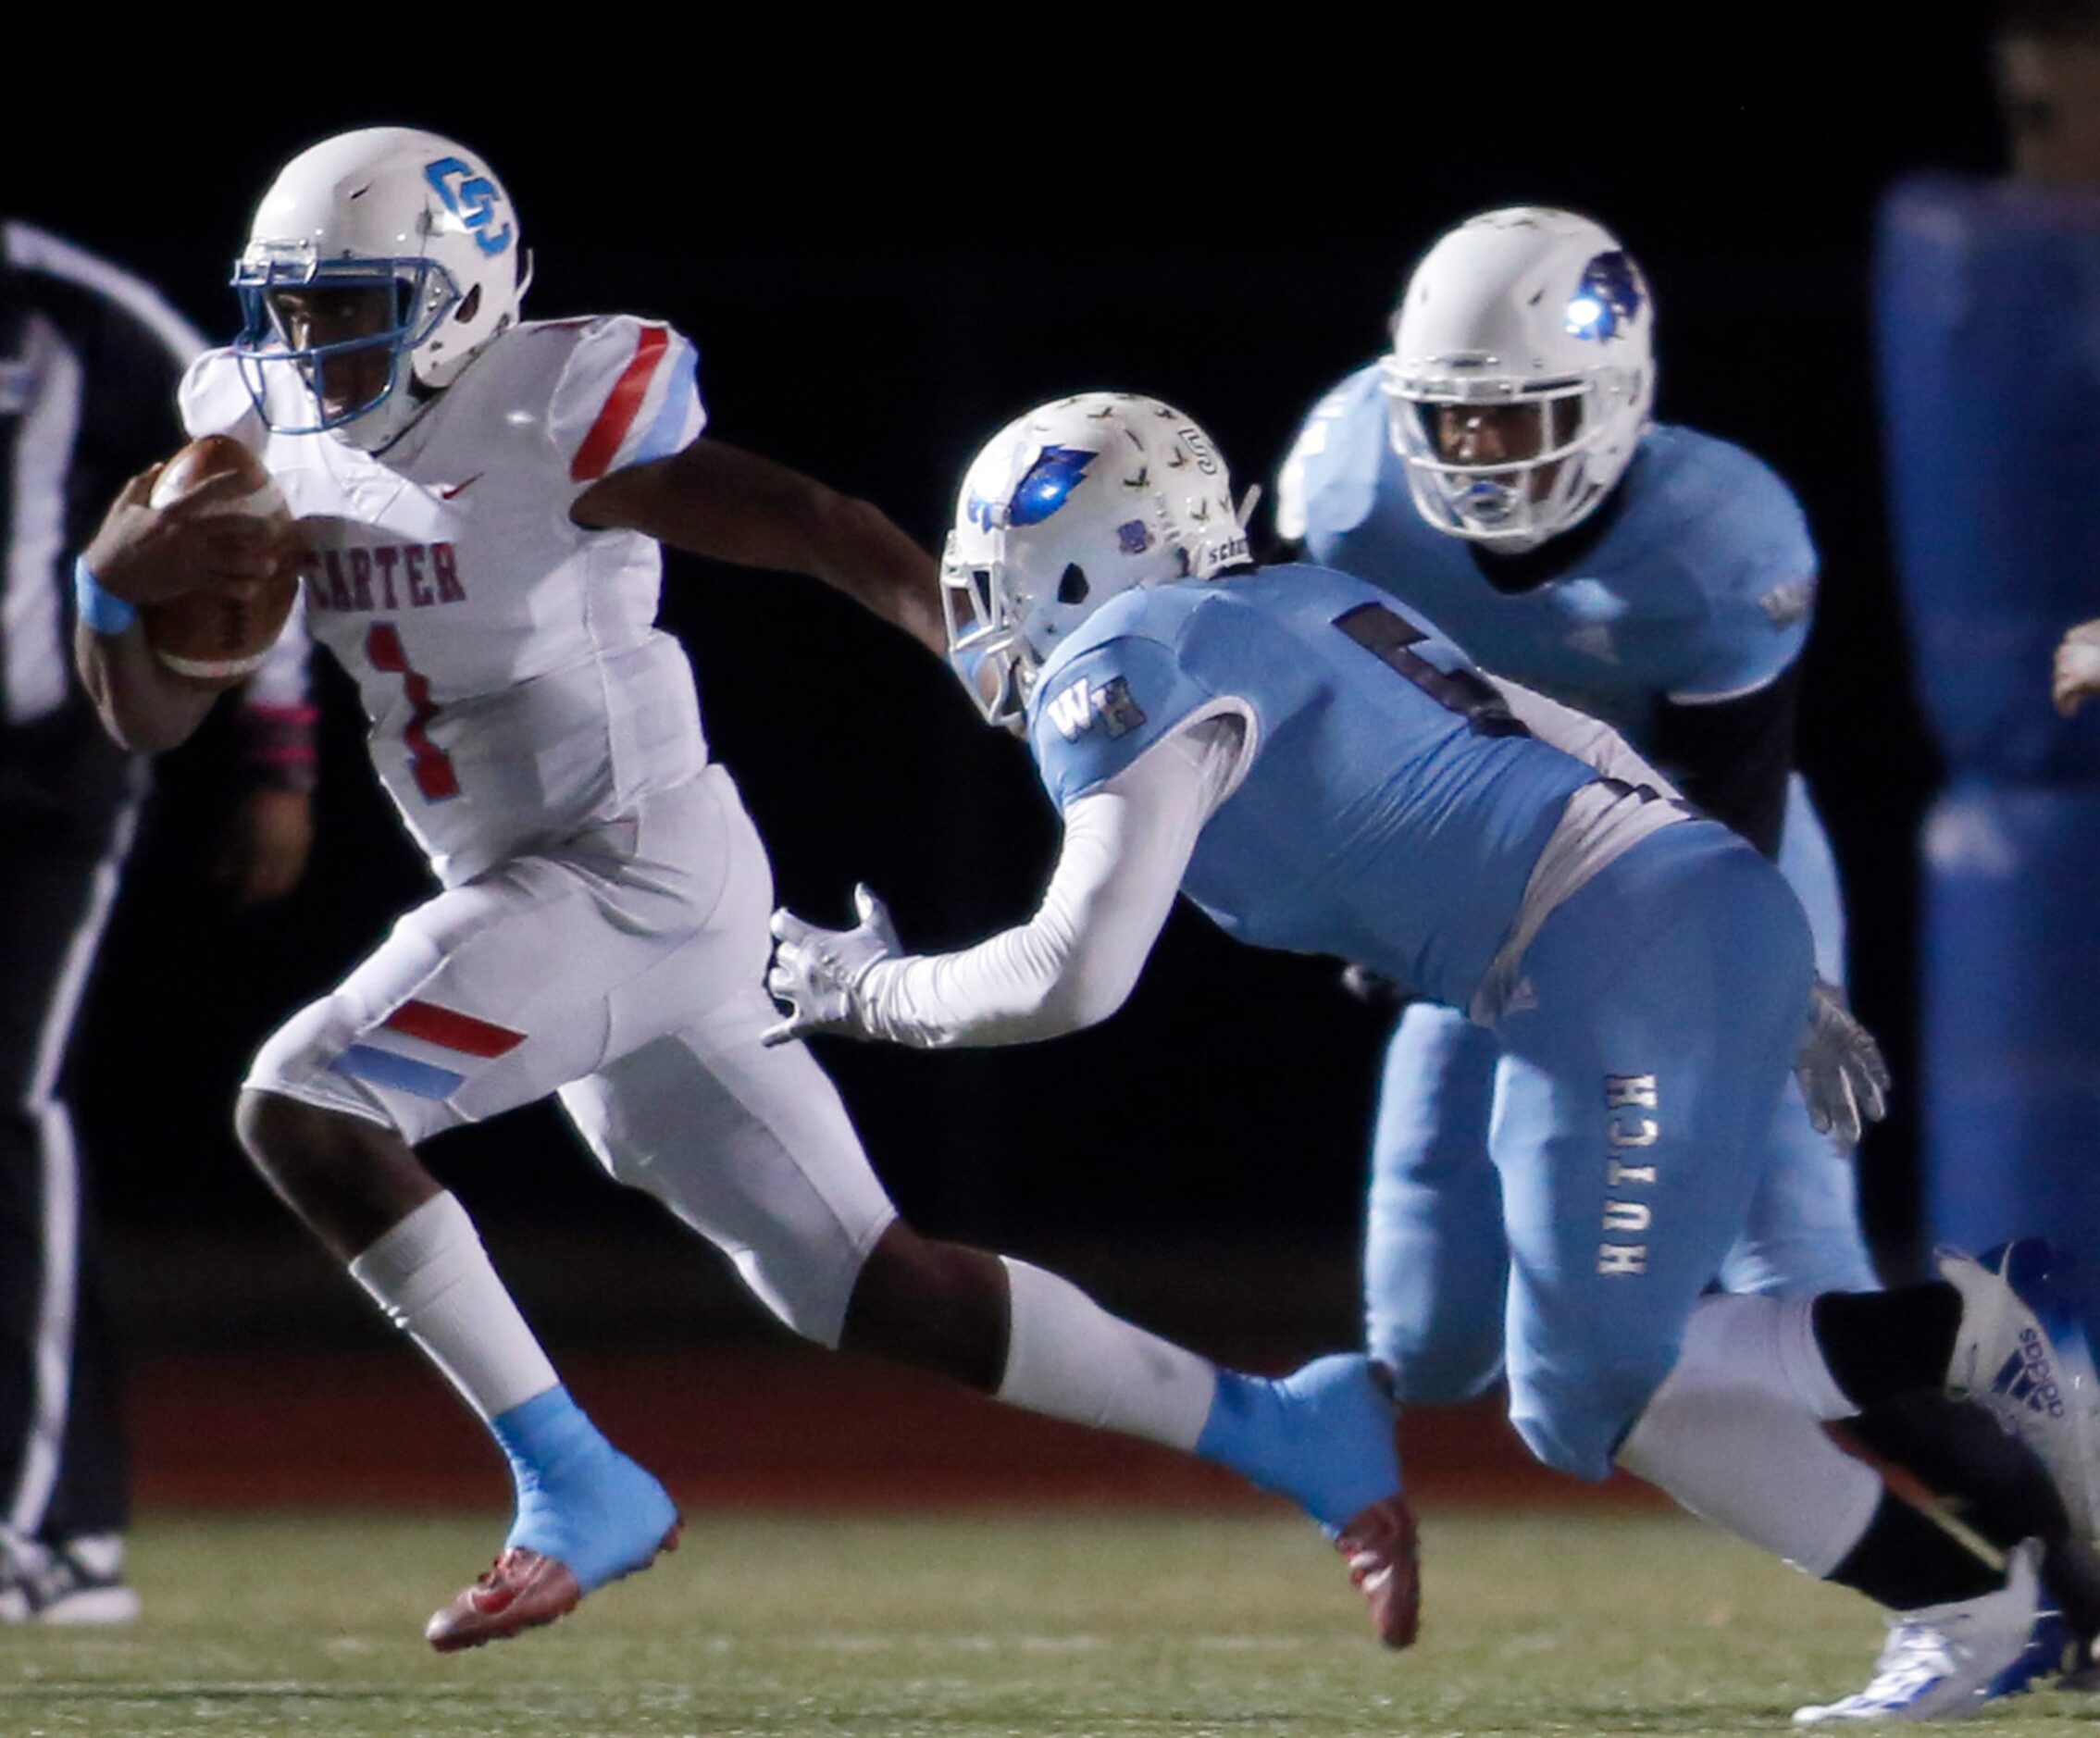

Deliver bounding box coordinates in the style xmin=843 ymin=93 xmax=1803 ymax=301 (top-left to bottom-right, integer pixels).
xmin=1277 ymin=205 xmax=2100 ymax=1695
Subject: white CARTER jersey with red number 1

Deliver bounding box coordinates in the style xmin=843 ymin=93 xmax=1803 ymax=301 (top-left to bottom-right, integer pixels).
xmin=180 ymin=315 xmax=708 ymax=886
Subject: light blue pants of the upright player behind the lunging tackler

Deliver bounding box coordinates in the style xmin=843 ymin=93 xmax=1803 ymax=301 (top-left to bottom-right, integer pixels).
xmin=1363 ymin=775 xmax=1880 ymax=1404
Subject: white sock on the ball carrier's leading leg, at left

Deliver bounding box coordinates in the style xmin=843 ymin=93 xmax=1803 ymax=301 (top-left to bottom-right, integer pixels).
xmin=351 ymin=1190 xmax=561 ymax=1421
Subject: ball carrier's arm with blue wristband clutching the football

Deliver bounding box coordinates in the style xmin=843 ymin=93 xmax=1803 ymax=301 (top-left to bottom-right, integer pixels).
xmin=73 ymin=466 xmax=288 ymax=753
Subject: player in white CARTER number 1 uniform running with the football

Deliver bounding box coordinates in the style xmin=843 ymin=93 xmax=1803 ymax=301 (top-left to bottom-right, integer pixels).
xmin=78 ymin=128 xmax=1413 ymax=1650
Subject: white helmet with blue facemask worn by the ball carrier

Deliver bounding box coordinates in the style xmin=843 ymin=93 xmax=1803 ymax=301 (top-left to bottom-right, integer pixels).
xmin=233 ymin=126 xmax=531 ymax=452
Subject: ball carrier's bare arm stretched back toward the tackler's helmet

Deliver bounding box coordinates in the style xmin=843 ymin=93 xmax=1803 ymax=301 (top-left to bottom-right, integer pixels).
xmin=569 ymin=437 xmax=947 ymax=657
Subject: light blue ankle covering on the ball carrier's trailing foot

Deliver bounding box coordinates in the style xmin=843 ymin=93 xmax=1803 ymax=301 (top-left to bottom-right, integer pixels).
xmin=1195 ymin=1354 xmax=1400 ymax=1534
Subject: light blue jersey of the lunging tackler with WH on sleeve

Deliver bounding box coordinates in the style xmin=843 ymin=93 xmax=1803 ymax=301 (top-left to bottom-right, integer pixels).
xmin=1029 ymin=566 xmax=1596 ymax=1008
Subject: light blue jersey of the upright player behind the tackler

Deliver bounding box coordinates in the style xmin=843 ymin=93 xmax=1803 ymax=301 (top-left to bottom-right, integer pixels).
xmin=1277 ymin=366 xmax=1817 ymax=739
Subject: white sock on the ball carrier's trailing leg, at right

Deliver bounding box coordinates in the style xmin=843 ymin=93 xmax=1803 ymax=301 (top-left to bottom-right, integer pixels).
xmin=998 ymin=1255 xmax=1218 ymax=1450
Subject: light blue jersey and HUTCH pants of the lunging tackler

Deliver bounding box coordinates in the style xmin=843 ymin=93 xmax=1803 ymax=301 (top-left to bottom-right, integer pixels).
xmin=1027 ymin=566 xmax=1810 ymax=1478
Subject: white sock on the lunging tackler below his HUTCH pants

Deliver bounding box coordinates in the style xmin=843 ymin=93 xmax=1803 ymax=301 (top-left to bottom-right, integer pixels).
xmin=1619 ymin=1297 xmax=1882 ymax=1581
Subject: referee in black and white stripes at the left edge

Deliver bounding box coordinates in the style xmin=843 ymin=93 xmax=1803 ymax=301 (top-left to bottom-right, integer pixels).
xmin=0 ymin=222 xmax=313 ymax=1622
